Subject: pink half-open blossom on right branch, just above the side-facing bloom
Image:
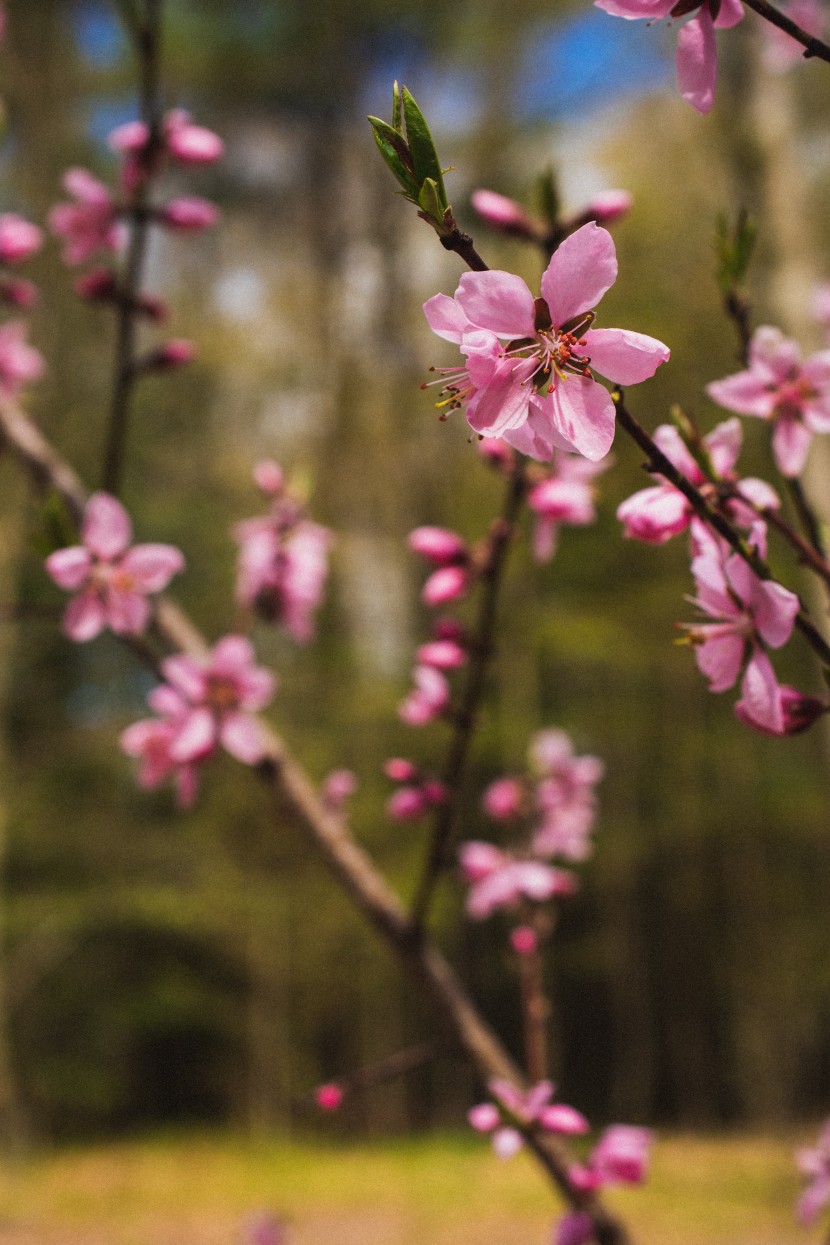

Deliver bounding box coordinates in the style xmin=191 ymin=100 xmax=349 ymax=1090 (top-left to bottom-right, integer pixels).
xmin=617 ymin=420 xmax=780 ymax=544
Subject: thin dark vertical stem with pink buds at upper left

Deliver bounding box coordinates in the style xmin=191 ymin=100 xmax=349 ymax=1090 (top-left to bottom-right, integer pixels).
xmin=102 ymin=0 xmax=163 ymax=497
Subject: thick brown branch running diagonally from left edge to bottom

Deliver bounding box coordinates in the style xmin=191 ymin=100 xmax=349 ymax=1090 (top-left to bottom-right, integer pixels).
xmin=0 ymin=390 xmax=630 ymax=1245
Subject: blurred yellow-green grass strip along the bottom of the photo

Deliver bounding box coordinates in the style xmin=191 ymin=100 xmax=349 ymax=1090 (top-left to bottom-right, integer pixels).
xmin=0 ymin=1135 xmax=820 ymax=1245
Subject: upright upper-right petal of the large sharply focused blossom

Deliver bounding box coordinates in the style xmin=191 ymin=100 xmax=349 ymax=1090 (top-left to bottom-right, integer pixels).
xmin=541 ymin=220 xmax=619 ymax=326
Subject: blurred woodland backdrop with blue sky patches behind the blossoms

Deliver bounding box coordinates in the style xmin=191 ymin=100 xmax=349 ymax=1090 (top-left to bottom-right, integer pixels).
xmin=0 ymin=0 xmax=830 ymax=1137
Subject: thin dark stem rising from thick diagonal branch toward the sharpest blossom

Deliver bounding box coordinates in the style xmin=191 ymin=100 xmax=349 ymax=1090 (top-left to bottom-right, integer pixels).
xmin=412 ymin=458 xmax=528 ymax=926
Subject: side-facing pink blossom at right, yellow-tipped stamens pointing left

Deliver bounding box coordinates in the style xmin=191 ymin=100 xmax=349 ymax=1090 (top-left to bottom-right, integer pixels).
xmin=683 ymin=523 xmax=799 ymax=735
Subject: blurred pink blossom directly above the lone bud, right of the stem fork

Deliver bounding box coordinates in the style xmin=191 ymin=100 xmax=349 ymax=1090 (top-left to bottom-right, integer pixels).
xmin=459 ymin=840 xmax=576 ymax=920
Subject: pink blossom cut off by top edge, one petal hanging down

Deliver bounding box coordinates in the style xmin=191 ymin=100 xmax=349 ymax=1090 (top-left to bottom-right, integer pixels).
xmin=594 ymin=0 xmax=743 ymax=112
